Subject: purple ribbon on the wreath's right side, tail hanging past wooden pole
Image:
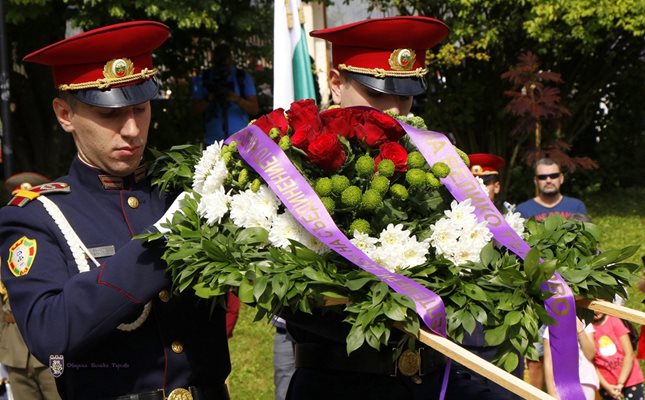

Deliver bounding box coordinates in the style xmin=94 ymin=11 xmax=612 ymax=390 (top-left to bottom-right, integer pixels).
xmin=401 ymin=123 xmax=585 ymax=400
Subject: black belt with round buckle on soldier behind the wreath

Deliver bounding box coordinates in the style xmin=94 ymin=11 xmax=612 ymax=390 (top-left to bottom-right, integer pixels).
xmin=295 ymin=343 xmax=445 ymax=376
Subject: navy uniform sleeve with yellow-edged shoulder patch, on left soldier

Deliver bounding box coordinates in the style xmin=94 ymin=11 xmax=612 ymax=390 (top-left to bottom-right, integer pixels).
xmin=0 ymin=202 xmax=169 ymax=365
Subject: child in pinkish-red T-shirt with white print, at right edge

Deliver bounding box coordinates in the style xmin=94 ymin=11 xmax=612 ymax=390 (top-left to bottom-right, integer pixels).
xmin=593 ymin=312 xmax=643 ymax=400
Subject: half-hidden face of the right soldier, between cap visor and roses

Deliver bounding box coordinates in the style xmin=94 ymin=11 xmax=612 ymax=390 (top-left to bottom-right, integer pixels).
xmin=330 ymin=71 xmax=412 ymax=115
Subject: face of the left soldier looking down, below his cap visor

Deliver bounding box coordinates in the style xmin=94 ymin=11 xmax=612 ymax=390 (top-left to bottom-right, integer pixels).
xmin=54 ymin=98 xmax=150 ymax=176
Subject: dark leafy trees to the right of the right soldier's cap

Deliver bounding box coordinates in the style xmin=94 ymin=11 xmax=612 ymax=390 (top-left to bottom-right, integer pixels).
xmin=370 ymin=0 xmax=645 ymax=201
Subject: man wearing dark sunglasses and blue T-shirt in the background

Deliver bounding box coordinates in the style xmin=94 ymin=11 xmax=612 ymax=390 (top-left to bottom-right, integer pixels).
xmin=517 ymin=158 xmax=588 ymax=221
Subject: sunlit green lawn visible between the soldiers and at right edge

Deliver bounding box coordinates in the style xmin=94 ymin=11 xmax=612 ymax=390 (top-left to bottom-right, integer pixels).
xmin=229 ymin=187 xmax=645 ymax=400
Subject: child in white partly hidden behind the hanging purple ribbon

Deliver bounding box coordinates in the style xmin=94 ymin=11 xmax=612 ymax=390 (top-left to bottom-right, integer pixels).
xmin=543 ymin=318 xmax=600 ymax=400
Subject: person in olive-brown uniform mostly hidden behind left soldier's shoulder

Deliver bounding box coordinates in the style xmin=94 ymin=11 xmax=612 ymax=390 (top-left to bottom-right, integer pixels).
xmin=0 ymin=172 xmax=60 ymax=400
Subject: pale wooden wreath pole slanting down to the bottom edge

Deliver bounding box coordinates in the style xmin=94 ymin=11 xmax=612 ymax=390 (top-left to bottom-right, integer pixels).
xmin=419 ymin=329 xmax=555 ymax=400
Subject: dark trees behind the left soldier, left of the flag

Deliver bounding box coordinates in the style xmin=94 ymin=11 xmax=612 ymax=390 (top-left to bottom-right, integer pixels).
xmin=5 ymin=0 xmax=273 ymax=177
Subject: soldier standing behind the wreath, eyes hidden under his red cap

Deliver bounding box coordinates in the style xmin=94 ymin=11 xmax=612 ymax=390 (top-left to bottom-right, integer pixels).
xmin=283 ymin=16 xmax=504 ymax=400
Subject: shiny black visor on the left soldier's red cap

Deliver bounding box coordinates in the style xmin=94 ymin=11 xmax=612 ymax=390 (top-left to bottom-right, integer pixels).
xmin=71 ymin=78 xmax=159 ymax=108
